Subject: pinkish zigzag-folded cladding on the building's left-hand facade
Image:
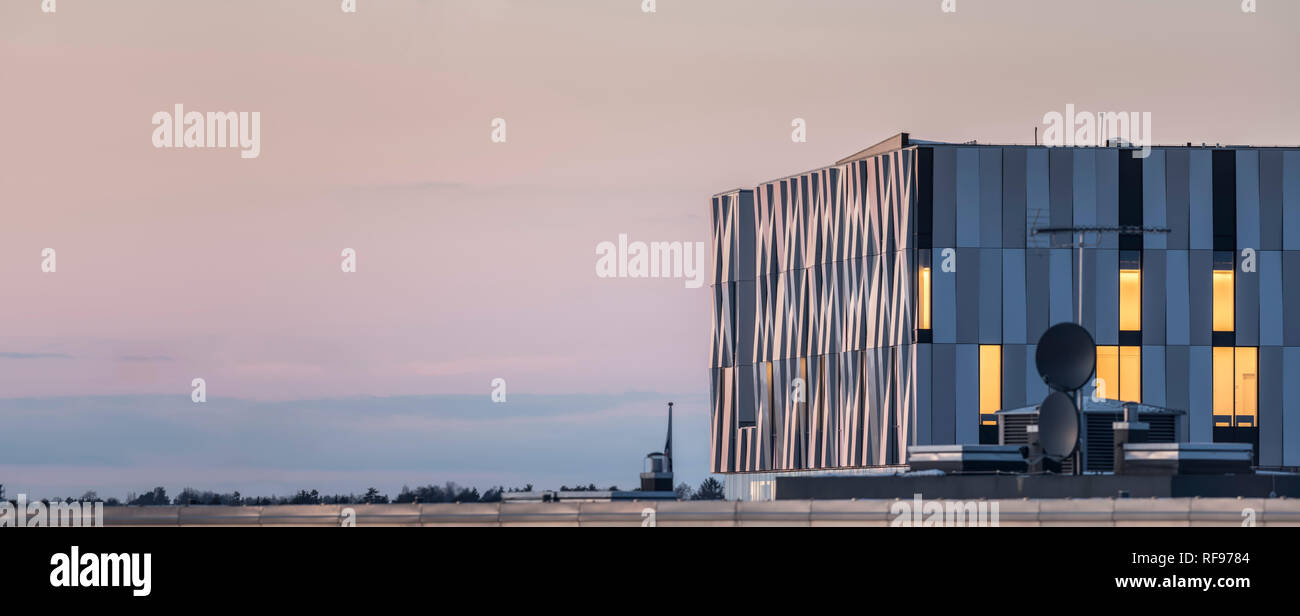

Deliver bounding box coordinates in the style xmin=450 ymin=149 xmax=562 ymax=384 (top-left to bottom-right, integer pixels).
xmin=711 ymin=149 xmax=928 ymax=472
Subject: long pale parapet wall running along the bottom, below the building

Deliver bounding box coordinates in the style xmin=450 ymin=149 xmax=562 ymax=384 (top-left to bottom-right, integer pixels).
xmin=96 ymin=498 xmax=1300 ymax=526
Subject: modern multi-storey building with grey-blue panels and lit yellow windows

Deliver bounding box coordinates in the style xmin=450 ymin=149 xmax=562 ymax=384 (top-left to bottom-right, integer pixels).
xmin=710 ymin=133 xmax=1300 ymax=491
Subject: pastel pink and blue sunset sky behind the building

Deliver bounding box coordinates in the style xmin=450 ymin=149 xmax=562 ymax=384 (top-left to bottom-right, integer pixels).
xmin=0 ymin=0 xmax=1300 ymax=498
